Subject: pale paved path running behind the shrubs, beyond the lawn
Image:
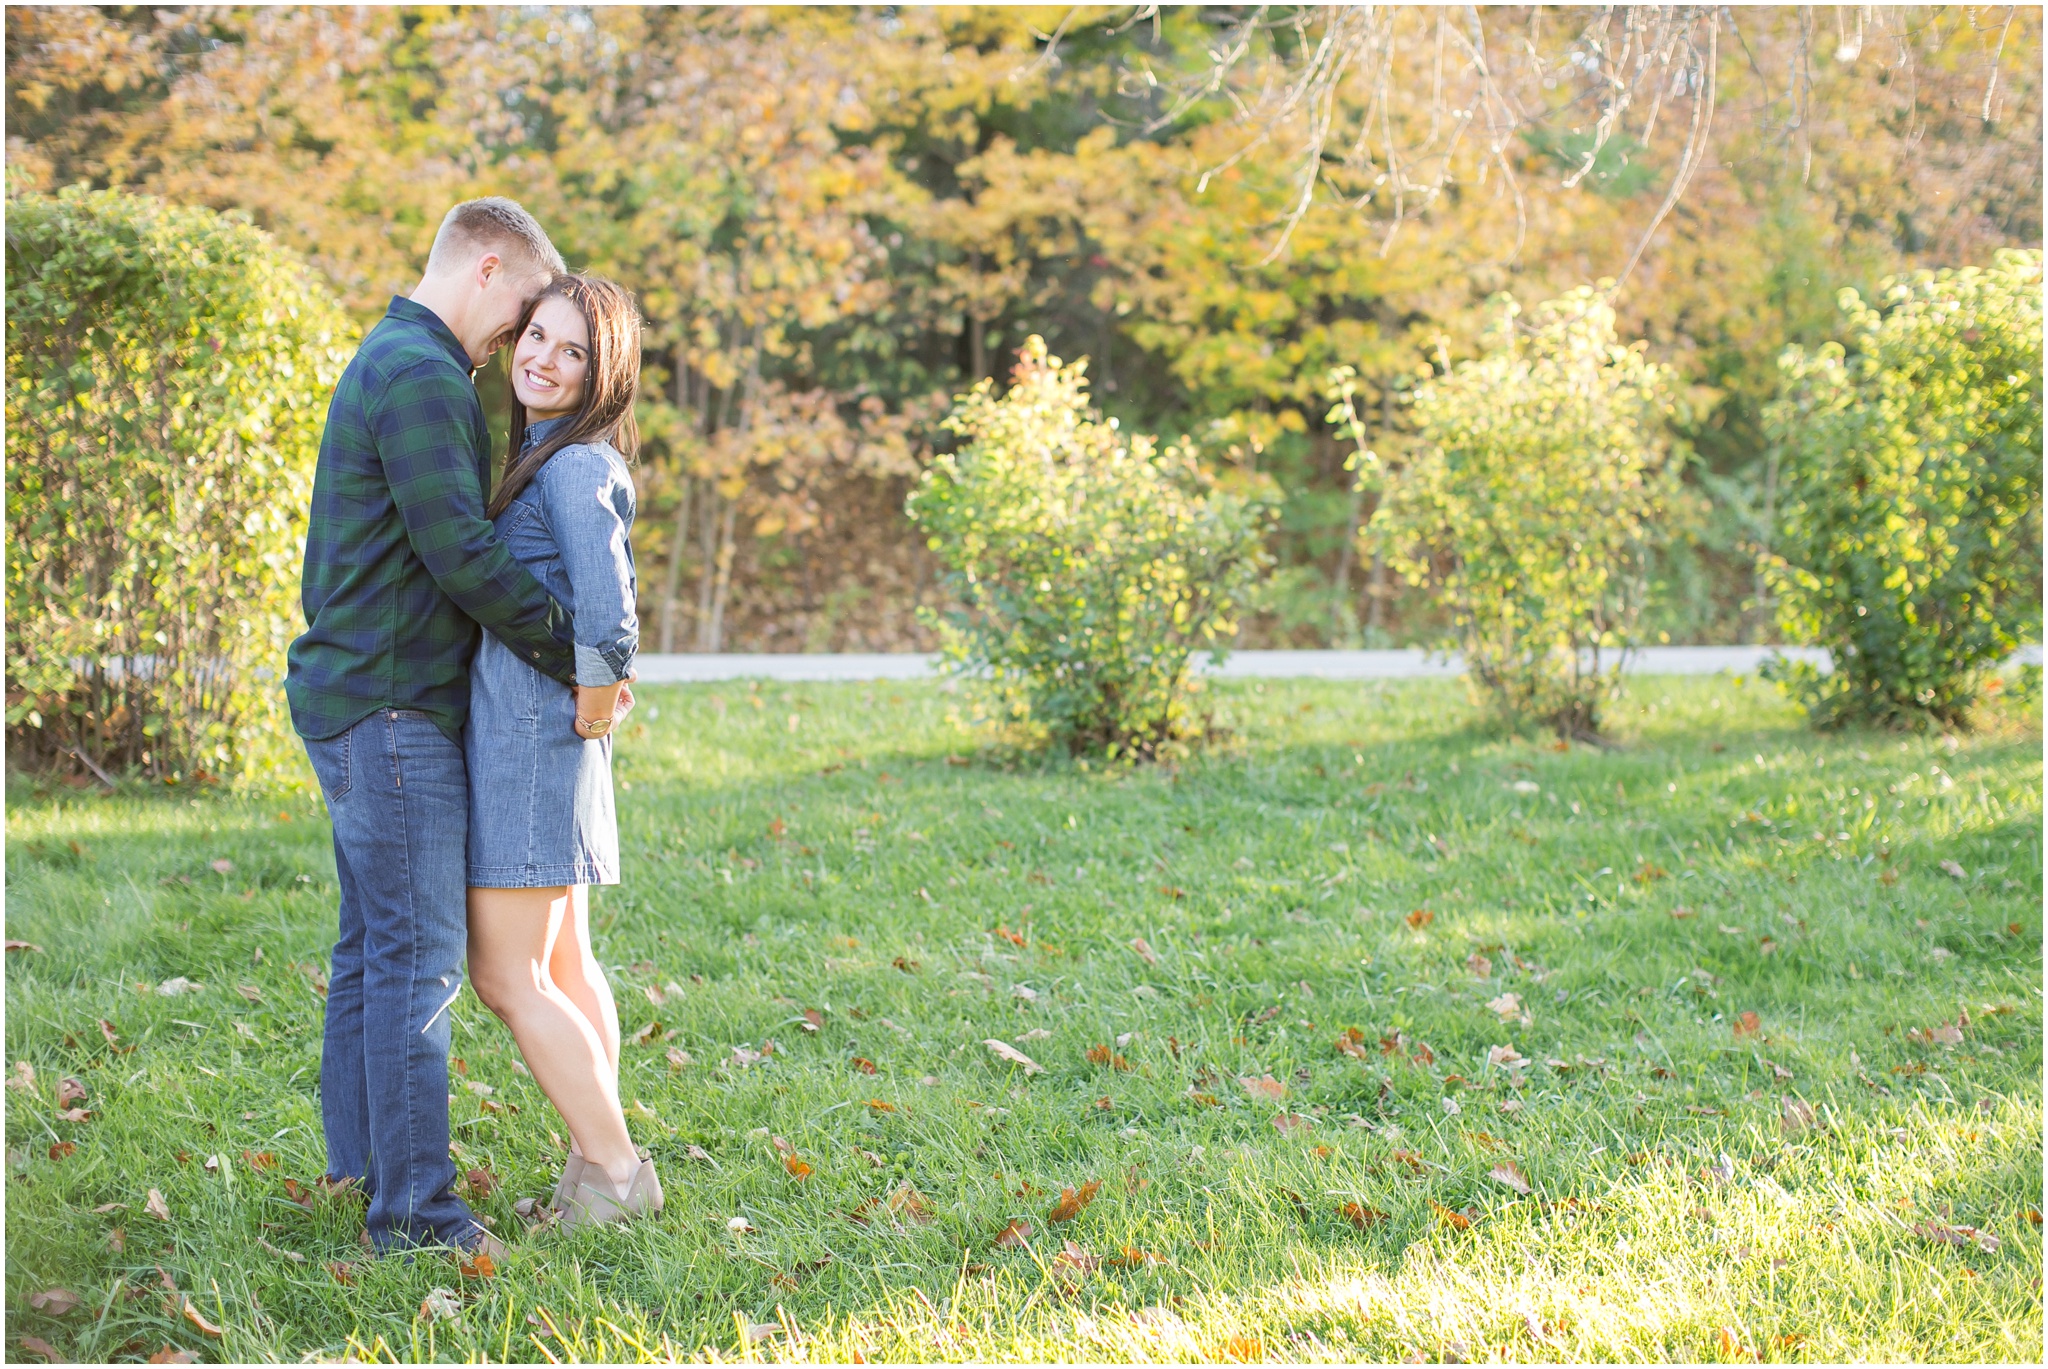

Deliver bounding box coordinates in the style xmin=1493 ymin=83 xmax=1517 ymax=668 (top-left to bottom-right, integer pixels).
xmin=635 ymin=646 xmax=2042 ymax=685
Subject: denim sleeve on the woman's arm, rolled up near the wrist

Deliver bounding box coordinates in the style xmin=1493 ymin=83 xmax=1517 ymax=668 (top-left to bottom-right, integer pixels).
xmin=541 ymin=447 xmax=639 ymax=685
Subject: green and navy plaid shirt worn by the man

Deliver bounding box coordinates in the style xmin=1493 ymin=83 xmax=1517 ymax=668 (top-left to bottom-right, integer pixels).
xmin=285 ymin=299 xmax=575 ymax=740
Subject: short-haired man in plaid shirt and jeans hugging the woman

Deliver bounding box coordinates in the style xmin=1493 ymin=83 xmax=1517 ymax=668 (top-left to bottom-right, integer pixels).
xmin=285 ymin=199 xmax=575 ymax=1254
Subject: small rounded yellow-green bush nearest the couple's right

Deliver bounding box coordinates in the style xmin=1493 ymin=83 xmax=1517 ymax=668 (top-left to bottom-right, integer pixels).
xmin=907 ymin=338 xmax=1268 ymax=758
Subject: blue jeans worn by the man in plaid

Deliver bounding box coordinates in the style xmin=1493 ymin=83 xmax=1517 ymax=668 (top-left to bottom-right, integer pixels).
xmin=305 ymin=709 xmax=481 ymax=1250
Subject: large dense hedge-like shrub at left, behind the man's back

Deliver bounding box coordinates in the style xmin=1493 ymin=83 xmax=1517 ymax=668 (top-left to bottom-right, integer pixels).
xmin=6 ymin=189 xmax=352 ymax=779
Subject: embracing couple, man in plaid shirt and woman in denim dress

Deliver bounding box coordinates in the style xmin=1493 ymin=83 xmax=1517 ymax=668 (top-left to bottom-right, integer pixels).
xmin=287 ymin=199 xmax=662 ymax=1254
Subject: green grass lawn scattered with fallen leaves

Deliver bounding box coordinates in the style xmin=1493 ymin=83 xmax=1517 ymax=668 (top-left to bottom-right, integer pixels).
xmin=6 ymin=680 xmax=2042 ymax=1361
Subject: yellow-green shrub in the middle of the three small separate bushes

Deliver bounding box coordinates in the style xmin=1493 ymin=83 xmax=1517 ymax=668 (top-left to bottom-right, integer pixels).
xmin=1366 ymin=289 xmax=1679 ymax=738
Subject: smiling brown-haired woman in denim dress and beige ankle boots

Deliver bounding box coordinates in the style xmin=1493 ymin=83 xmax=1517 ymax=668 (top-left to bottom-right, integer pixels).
xmin=465 ymin=277 xmax=662 ymax=1226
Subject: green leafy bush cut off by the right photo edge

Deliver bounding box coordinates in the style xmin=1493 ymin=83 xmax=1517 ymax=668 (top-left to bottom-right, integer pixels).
xmin=1767 ymin=252 xmax=2042 ymax=728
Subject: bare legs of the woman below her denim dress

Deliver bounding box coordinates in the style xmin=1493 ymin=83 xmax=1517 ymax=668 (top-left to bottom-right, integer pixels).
xmin=469 ymin=887 xmax=639 ymax=1185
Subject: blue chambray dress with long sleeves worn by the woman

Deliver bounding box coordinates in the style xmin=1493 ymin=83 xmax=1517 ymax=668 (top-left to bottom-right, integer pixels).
xmin=463 ymin=418 xmax=639 ymax=889
